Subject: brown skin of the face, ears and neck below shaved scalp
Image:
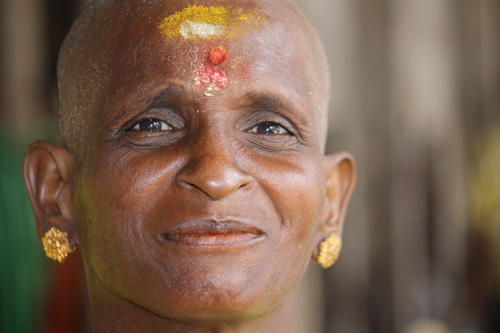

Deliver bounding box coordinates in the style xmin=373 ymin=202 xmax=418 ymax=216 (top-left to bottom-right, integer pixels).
xmin=20 ymin=2 xmax=355 ymax=332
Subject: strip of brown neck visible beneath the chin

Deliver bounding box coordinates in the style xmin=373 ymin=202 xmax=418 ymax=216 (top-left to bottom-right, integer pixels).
xmin=89 ymin=276 xmax=293 ymax=333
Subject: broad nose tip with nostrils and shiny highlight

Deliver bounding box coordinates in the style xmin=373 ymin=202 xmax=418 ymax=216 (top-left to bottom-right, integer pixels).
xmin=176 ymin=147 xmax=253 ymax=200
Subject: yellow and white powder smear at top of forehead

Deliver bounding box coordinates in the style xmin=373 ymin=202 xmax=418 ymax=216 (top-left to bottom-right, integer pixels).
xmin=159 ymin=5 xmax=267 ymax=39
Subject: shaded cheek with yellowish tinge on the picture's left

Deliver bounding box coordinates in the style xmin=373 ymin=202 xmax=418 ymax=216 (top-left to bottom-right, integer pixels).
xmin=74 ymin=150 xmax=175 ymax=293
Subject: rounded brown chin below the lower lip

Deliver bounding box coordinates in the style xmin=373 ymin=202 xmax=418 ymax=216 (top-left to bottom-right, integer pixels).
xmin=130 ymin=266 xmax=293 ymax=325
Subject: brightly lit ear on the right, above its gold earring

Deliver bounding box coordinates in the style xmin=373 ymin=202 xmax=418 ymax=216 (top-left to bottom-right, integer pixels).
xmin=313 ymin=152 xmax=356 ymax=259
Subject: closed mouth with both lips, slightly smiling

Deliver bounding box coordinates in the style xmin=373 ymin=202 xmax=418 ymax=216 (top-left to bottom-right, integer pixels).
xmin=161 ymin=219 xmax=266 ymax=249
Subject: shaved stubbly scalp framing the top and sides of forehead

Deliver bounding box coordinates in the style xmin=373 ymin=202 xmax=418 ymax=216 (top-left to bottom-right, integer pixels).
xmin=57 ymin=0 xmax=330 ymax=161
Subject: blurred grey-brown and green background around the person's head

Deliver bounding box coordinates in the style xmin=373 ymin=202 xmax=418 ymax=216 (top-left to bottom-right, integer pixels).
xmin=0 ymin=0 xmax=500 ymax=333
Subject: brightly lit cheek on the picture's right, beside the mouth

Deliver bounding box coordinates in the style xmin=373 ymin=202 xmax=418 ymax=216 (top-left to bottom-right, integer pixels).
xmin=249 ymin=154 xmax=326 ymax=290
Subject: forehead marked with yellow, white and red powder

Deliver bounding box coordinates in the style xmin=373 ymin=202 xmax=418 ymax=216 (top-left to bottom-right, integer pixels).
xmin=91 ymin=2 xmax=313 ymax=123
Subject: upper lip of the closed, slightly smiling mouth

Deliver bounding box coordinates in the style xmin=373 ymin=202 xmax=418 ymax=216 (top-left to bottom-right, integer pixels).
xmin=163 ymin=218 xmax=266 ymax=237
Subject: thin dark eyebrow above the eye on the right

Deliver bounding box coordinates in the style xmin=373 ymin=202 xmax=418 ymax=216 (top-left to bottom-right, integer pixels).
xmin=239 ymin=92 xmax=310 ymax=124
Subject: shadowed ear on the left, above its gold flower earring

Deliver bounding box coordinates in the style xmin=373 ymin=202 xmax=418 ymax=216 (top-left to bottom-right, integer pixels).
xmin=23 ymin=140 xmax=78 ymax=247
